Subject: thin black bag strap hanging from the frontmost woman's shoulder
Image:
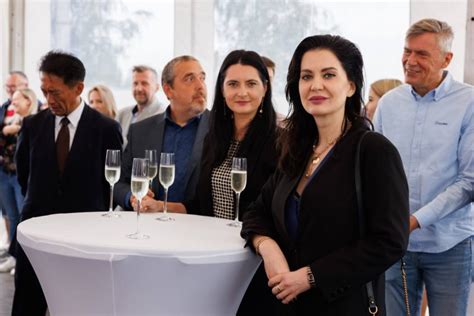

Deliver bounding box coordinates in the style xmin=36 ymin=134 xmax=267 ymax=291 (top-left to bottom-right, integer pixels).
xmin=355 ymin=131 xmax=379 ymax=315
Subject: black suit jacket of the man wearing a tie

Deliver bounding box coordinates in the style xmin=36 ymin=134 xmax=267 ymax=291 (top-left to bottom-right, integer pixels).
xmin=16 ymin=105 xmax=122 ymax=220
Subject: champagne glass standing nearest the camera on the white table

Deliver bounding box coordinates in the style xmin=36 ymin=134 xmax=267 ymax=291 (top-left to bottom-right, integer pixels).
xmin=127 ymin=158 xmax=150 ymax=239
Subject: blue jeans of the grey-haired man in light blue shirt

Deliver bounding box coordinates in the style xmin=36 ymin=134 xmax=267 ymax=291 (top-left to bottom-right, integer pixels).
xmin=385 ymin=237 xmax=473 ymax=316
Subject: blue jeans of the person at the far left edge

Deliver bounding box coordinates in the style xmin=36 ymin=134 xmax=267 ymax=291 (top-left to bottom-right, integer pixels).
xmin=0 ymin=167 xmax=24 ymax=241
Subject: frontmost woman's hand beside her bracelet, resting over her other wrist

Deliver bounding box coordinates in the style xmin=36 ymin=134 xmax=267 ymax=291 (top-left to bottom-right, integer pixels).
xmin=268 ymin=267 xmax=311 ymax=304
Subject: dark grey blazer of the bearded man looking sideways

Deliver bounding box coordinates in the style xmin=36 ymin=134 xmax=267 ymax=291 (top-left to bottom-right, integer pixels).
xmin=114 ymin=110 xmax=209 ymax=210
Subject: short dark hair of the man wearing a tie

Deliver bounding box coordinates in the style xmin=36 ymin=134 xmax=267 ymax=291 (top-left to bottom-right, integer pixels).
xmin=39 ymin=50 xmax=86 ymax=87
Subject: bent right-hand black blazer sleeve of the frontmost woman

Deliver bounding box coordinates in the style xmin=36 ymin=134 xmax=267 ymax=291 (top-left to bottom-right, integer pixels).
xmin=310 ymin=133 xmax=409 ymax=301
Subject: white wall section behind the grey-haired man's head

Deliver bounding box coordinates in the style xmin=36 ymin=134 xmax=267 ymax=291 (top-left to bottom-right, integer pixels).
xmin=410 ymin=0 xmax=468 ymax=81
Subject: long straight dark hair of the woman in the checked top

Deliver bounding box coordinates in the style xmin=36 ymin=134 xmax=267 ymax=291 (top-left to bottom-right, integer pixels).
xmin=207 ymin=50 xmax=276 ymax=167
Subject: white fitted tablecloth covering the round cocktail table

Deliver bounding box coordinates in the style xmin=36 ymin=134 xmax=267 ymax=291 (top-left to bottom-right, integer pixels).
xmin=18 ymin=212 xmax=260 ymax=316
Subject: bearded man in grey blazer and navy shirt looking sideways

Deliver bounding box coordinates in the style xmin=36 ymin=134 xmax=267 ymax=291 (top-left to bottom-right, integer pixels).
xmin=114 ymin=56 xmax=209 ymax=212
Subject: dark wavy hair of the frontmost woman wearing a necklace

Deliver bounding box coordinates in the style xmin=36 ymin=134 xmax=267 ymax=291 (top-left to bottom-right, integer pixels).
xmin=278 ymin=35 xmax=366 ymax=177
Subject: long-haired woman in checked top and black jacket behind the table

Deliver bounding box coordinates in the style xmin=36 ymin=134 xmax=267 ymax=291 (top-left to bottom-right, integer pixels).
xmin=144 ymin=50 xmax=278 ymax=315
